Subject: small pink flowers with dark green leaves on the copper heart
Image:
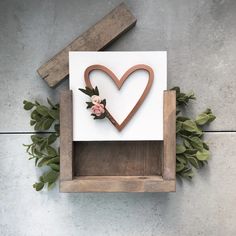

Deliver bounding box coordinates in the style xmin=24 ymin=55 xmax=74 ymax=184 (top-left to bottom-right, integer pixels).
xmin=79 ymin=86 xmax=107 ymax=119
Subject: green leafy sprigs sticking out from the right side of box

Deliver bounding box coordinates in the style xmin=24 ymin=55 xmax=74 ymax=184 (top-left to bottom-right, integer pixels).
xmin=172 ymin=87 xmax=216 ymax=180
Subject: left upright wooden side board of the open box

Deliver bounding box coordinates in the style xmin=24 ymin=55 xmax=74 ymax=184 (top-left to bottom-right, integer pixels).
xmin=60 ymin=90 xmax=73 ymax=181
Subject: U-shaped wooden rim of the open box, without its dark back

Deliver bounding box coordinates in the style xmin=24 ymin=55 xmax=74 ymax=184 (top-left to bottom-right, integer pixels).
xmin=60 ymin=90 xmax=176 ymax=192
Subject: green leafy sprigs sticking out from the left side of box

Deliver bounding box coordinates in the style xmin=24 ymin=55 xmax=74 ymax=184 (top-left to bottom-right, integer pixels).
xmin=23 ymin=99 xmax=60 ymax=191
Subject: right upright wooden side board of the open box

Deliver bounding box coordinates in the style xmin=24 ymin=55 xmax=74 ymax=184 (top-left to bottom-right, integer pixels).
xmin=162 ymin=90 xmax=176 ymax=180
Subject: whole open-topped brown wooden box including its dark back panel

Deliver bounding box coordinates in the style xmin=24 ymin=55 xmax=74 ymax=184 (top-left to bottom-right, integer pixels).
xmin=60 ymin=90 xmax=176 ymax=192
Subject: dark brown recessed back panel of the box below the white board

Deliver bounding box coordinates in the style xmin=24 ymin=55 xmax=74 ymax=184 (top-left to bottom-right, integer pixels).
xmin=74 ymin=141 xmax=163 ymax=176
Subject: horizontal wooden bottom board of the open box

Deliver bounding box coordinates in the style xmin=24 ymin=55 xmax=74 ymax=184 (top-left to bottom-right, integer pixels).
xmin=60 ymin=176 xmax=175 ymax=192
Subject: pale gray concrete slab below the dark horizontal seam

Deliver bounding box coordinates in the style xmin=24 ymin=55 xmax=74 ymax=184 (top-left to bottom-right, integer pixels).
xmin=0 ymin=133 xmax=236 ymax=236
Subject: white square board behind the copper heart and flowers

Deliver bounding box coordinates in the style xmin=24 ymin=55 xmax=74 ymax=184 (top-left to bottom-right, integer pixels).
xmin=69 ymin=51 xmax=167 ymax=141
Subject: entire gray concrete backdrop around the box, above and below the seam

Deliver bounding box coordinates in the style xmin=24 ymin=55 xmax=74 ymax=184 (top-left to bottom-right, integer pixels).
xmin=0 ymin=0 xmax=236 ymax=236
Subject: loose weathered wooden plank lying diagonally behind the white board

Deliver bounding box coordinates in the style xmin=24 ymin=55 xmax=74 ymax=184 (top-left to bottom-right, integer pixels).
xmin=38 ymin=3 xmax=137 ymax=87
